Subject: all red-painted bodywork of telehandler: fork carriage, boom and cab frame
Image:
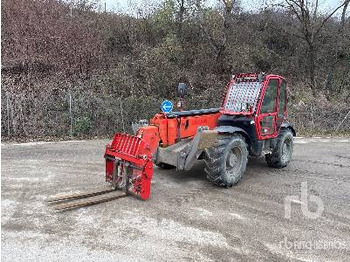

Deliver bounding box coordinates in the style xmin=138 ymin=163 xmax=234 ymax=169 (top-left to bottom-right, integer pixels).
xmin=105 ymin=74 xmax=286 ymax=200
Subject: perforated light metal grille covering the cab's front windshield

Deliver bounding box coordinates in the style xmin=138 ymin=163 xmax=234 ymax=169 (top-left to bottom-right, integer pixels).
xmin=224 ymin=82 xmax=262 ymax=112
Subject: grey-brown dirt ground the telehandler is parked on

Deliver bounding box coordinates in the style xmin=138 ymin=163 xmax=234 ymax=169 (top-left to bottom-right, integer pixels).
xmin=1 ymin=138 xmax=350 ymax=262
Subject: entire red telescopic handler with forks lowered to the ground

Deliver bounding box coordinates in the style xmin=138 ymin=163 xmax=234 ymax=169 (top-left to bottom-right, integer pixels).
xmin=48 ymin=73 xmax=296 ymax=211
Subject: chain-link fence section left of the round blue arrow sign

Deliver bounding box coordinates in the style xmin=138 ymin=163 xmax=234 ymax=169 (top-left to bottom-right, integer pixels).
xmin=1 ymin=91 xmax=161 ymax=139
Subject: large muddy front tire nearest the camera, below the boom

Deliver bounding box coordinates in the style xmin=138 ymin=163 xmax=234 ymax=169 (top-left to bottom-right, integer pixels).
xmin=205 ymin=134 xmax=248 ymax=187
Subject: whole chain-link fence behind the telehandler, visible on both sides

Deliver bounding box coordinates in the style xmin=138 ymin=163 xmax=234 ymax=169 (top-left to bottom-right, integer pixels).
xmin=1 ymin=90 xmax=350 ymax=139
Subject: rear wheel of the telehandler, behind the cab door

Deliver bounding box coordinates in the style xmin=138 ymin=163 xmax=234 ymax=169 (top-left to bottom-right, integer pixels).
xmin=265 ymin=129 xmax=293 ymax=168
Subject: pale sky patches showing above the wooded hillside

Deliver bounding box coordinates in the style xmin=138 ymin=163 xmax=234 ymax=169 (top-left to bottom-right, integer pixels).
xmin=99 ymin=0 xmax=341 ymax=14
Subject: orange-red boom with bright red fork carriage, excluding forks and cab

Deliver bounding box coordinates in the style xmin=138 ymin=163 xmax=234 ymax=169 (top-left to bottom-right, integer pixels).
xmin=105 ymin=113 xmax=220 ymax=200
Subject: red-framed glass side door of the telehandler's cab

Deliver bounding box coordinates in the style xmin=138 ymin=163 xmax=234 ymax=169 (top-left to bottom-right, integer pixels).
xmin=256 ymin=77 xmax=280 ymax=139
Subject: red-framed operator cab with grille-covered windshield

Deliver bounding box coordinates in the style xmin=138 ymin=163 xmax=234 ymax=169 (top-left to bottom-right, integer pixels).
xmin=219 ymin=73 xmax=287 ymax=140
